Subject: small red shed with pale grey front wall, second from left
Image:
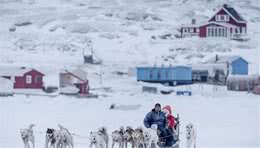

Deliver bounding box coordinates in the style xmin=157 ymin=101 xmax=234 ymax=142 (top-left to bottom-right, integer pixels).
xmin=60 ymin=68 xmax=89 ymax=94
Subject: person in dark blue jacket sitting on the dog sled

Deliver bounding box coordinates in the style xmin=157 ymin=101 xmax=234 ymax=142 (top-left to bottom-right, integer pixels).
xmin=144 ymin=103 xmax=168 ymax=145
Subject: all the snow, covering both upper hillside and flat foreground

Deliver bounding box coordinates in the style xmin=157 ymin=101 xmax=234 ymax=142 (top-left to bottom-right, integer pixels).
xmin=0 ymin=0 xmax=260 ymax=148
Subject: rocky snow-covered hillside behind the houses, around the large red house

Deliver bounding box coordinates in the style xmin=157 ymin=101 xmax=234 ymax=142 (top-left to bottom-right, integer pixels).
xmin=0 ymin=0 xmax=260 ymax=70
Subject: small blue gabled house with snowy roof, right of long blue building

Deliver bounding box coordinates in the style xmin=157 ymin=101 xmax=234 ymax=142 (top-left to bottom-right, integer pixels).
xmin=208 ymin=55 xmax=248 ymax=75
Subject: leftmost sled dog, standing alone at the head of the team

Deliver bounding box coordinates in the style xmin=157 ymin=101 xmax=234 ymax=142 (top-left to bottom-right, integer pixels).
xmin=20 ymin=124 xmax=35 ymax=148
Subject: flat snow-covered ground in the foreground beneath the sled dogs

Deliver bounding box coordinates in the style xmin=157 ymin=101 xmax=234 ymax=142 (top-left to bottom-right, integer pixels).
xmin=0 ymin=82 xmax=260 ymax=148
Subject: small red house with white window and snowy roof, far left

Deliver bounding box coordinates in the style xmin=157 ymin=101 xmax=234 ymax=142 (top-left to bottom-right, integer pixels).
xmin=0 ymin=67 xmax=44 ymax=89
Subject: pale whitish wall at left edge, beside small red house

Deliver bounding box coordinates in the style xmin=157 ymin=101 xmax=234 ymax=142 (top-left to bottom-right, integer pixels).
xmin=0 ymin=77 xmax=14 ymax=96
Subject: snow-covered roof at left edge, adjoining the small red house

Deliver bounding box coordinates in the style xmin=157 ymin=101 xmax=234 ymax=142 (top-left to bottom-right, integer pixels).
xmin=0 ymin=66 xmax=32 ymax=77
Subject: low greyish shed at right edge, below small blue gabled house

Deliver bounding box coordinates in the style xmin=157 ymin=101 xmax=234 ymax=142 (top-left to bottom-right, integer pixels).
xmin=227 ymin=75 xmax=259 ymax=91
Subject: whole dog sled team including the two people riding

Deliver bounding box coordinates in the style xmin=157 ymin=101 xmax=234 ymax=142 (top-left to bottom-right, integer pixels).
xmin=20 ymin=103 xmax=196 ymax=148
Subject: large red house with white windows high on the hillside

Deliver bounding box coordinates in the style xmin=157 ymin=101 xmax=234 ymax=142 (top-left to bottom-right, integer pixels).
xmin=180 ymin=4 xmax=247 ymax=39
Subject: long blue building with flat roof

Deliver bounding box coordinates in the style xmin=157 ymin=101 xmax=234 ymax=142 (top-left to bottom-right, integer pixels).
xmin=137 ymin=66 xmax=192 ymax=86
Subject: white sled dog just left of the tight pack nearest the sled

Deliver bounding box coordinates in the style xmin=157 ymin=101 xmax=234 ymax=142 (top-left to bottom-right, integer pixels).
xmin=90 ymin=127 xmax=109 ymax=148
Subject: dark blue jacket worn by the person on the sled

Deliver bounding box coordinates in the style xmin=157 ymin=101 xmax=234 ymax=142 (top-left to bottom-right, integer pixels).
xmin=144 ymin=109 xmax=167 ymax=128
